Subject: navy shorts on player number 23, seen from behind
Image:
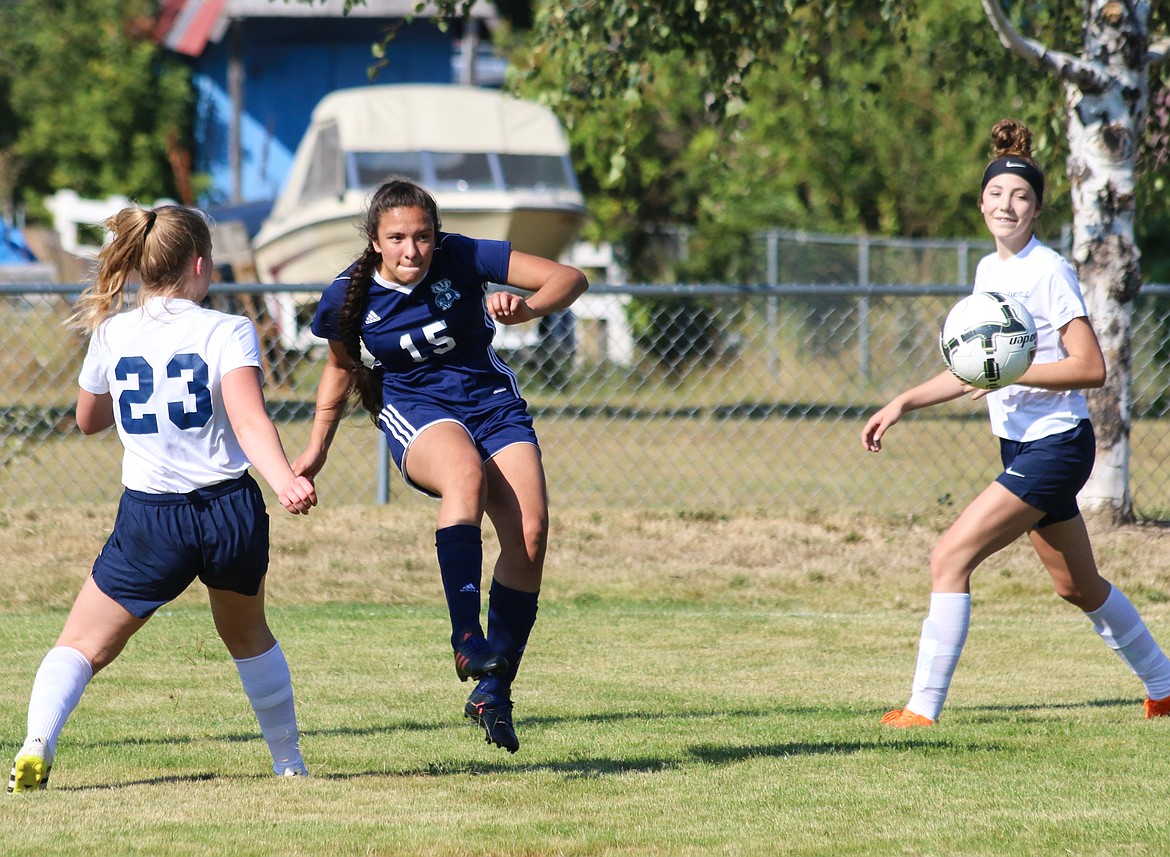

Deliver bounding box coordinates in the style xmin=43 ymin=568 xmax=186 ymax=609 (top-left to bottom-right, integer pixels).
xmin=92 ymin=473 xmax=268 ymax=619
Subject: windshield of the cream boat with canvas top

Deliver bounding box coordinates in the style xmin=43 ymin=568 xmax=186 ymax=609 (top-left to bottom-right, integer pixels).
xmin=346 ymin=152 xmax=577 ymax=192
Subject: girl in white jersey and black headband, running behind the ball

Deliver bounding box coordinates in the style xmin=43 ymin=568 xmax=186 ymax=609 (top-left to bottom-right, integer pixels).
xmin=861 ymin=119 xmax=1170 ymax=728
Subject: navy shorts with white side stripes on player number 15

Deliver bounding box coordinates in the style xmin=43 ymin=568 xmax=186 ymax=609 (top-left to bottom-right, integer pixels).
xmin=378 ymin=396 xmax=539 ymax=496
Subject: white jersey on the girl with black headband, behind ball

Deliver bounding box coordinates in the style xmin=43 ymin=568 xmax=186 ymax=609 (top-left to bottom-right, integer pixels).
xmin=975 ymin=235 xmax=1089 ymax=440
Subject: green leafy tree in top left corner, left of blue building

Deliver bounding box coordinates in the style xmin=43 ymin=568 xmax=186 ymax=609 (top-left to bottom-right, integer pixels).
xmin=0 ymin=0 xmax=194 ymax=217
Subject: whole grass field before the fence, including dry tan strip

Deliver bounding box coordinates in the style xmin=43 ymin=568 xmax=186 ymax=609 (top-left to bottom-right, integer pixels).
xmin=0 ymin=505 xmax=1170 ymax=856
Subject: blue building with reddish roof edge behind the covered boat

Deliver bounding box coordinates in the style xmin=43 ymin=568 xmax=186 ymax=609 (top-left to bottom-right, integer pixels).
xmin=158 ymin=0 xmax=502 ymax=215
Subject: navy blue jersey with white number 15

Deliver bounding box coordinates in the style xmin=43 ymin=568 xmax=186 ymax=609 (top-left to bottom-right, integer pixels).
xmin=312 ymin=232 xmax=519 ymax=413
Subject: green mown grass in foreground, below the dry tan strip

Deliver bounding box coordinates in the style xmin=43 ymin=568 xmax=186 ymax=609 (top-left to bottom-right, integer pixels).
xmin=0 ymin=590 xmax=1170 ymax=856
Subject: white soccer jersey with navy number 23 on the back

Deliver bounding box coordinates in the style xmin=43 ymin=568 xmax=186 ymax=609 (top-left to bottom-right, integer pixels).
xmin=78 ymin=297 xmax=260 ymax=494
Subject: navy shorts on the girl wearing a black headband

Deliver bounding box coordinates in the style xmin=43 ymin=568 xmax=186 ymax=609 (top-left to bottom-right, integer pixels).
xmin=996 ymin=419 xmax=1096 ymax=529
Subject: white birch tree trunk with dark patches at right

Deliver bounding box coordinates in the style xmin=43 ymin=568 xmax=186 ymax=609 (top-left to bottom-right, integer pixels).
xmin=983 ymin=0 xmax=1162 ymax=523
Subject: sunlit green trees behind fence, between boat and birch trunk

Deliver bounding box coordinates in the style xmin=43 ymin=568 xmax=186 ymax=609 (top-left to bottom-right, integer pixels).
xmin=498 ymin=0 xmax=1068 ymax=279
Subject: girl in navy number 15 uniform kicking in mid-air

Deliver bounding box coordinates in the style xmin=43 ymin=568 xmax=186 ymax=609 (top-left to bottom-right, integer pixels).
xmin=294 ymin=179 xmax=589 ymax=753
